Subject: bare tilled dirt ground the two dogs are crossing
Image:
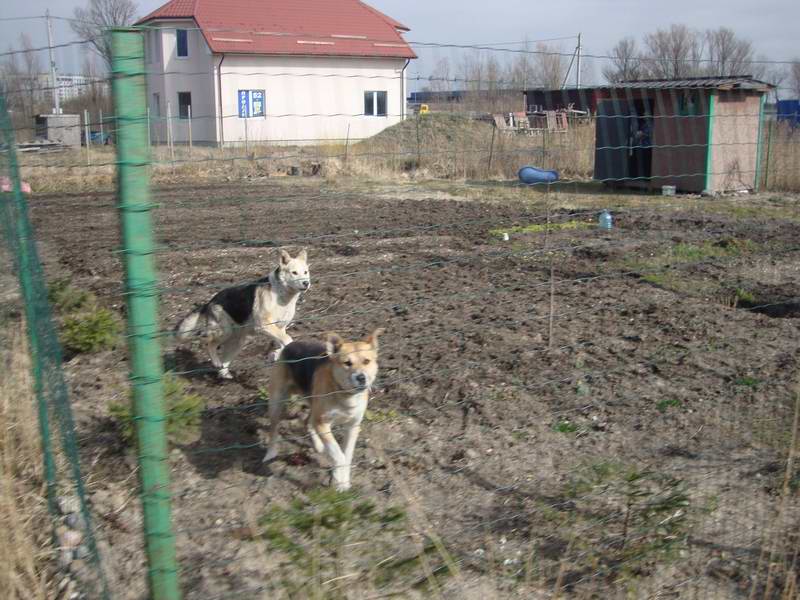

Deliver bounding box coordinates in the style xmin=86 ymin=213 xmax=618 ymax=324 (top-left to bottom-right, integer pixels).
xmin=23 ymin=178 xmax=800 ymax=600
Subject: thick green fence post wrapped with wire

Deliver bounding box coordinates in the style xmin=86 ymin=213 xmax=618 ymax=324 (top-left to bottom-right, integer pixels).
xmin=111 ymin=28 xmax=180 ymax=600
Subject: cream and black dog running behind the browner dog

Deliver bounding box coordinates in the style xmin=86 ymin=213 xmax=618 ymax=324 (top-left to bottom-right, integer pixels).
xmin=176 ymin=250 xmax=311 ymax=379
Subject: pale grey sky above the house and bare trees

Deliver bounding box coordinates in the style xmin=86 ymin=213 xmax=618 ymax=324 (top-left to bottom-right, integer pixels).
xmin=0 ymin=0 xmax=800 ymax=89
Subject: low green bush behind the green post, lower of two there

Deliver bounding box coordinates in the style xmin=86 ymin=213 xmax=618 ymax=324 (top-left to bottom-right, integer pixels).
xmin=109 ymin=373 xmax=206 ymax=444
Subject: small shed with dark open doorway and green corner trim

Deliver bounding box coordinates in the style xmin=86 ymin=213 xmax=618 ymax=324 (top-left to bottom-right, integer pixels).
xmin=594 ymin=75 xmax=773 ymax=192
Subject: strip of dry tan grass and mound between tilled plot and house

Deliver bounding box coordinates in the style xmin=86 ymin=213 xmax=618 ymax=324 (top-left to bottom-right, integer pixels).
xmin=20 ymin=114 xmax=595 ymax=193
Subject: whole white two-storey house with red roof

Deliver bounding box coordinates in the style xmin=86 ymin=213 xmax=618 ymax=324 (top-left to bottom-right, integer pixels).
xmin=137 ymin=0 xmax=416 ymax=145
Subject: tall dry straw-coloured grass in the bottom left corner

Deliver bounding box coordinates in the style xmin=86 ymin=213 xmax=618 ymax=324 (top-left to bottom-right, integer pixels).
xmin=0 ymin=329 xmax=54 ymax=600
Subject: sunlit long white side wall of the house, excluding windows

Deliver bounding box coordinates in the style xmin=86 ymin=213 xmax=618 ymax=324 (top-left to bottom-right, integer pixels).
xmin=220 ymin=55 xmax=406 ymax=145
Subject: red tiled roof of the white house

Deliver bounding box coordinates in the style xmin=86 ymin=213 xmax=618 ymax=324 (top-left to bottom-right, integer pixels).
xmin=137 ymin=0 xmax=416 ymax=58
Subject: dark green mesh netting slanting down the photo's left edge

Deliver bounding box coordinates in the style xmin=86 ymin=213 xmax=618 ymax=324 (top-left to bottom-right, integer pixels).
xmin=0 ymin=94 xmax=108 ymax=598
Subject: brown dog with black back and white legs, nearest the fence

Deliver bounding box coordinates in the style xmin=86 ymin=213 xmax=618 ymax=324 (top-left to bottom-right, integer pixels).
xmin=264 ymin=329 xmax=383 ymax=491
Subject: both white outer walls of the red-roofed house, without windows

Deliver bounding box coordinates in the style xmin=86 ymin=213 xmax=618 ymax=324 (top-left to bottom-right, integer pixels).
xmin=145 ymin=20 xmax=407 ymax=145
